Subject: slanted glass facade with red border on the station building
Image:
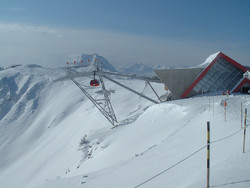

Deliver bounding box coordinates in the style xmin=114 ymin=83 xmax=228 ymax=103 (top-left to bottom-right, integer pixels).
xmin=181 ymin=52 xmax=248 ymax=98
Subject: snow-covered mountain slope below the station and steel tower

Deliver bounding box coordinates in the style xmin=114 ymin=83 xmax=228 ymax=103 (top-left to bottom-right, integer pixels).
xmin=0 ymin=65 xmax=250 ymax=188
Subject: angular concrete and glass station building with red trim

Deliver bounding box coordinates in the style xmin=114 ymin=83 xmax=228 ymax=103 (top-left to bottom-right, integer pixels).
xmin=154 ymin=52 xmax=250 ymax=99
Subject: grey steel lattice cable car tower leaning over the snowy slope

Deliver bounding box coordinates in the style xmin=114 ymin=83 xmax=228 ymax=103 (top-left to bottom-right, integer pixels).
xmin=66 ymin=59 xmax=162 ymax=126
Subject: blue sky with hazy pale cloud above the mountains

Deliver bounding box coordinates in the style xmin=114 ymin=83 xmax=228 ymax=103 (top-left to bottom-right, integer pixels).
xmin=0 ymin=0 xmax=250 ymax=67
